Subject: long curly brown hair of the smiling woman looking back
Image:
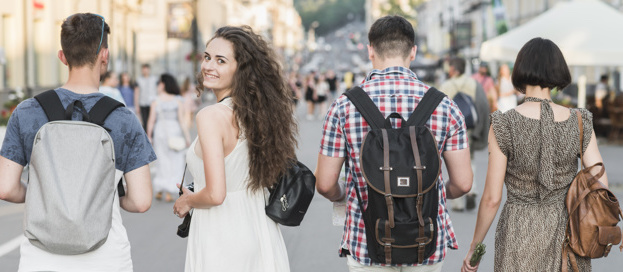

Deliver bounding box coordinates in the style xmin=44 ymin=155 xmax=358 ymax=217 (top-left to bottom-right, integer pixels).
xmin=197 ymin=26 xmax=298 ymax=191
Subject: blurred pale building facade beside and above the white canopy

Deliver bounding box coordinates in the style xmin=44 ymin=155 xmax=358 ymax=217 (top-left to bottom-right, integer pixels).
xmin=417 ymin=0 xmax=623 ymax=83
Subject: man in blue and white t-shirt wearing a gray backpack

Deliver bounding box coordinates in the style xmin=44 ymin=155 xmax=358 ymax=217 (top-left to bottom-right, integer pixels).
xmin=0 ymin=13 xmax=156 ymax=271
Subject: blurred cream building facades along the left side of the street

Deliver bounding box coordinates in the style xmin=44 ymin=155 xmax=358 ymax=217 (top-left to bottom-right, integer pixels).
xmin=0 ymin=0 xmax=304 ymax=98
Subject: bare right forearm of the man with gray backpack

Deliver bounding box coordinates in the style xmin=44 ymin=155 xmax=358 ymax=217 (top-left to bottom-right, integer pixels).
xmin=119 ymin=164 xmax=152 ymax=213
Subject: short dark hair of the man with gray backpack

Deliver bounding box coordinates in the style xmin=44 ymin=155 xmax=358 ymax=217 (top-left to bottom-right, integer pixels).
xmin=61 ymin=13 xmax=110 ymax=69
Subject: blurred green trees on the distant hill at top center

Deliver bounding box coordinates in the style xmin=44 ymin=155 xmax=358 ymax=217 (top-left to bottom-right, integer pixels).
xmin=294 ymin=0 xmax=365 ymax=35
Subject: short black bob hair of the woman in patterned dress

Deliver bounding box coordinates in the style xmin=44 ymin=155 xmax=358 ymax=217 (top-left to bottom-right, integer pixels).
xmin=511 ymin=38 xmax=571 ymax=93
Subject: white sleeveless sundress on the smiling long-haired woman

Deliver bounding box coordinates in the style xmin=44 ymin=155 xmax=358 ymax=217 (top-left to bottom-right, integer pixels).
xmin=185 ymin=99 xmax=290 ymax=272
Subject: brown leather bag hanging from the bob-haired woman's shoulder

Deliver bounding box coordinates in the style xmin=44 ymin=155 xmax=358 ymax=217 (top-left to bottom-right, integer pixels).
xmin=562 ymin=111 xmax=623 ymax=272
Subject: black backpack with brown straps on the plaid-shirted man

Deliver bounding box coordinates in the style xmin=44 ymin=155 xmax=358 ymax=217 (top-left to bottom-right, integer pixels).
xmin=345 ymin=87 xmax=445 ymax=264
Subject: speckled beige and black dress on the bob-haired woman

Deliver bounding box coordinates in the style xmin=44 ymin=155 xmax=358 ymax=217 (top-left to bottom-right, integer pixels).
xmin=491 ymin=97 xmax=593 ymax=271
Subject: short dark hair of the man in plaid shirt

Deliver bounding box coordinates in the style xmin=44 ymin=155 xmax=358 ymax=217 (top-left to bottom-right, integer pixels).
xmin=368 ymin=16 xmax=415 ymax=59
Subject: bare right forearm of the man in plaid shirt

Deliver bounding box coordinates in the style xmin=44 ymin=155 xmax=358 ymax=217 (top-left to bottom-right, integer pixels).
xmin=443 ymin=147 xmax=474 ymax=199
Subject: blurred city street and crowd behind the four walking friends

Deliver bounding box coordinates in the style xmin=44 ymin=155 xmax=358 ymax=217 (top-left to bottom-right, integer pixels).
xmin=0 ymin=0 xmax=623 ymax=272
